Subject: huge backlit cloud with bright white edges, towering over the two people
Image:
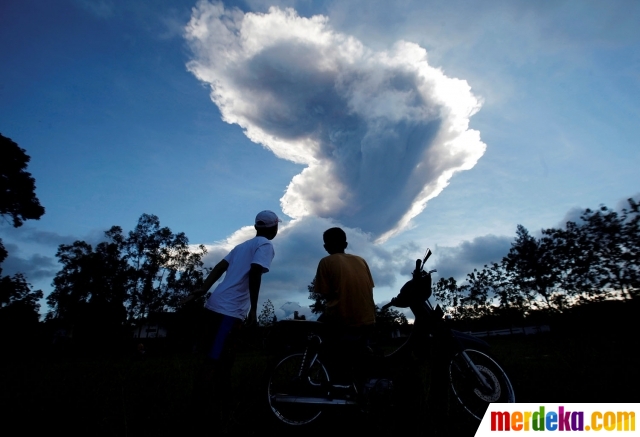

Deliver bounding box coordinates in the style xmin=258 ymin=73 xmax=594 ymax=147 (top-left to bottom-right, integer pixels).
xmin=185 ymin=1 xmax=486 ymax=241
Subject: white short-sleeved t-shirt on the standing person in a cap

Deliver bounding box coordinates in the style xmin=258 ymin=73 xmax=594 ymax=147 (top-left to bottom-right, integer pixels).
xmin=205 ymin=237 xmax=275 ymax=320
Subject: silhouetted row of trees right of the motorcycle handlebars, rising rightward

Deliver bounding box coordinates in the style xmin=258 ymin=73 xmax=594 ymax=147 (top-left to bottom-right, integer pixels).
xmin=433 ymin=199 xmax=640 ymax=320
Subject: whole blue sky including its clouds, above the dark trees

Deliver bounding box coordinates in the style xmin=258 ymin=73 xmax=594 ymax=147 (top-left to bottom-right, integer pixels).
xmin=0 ymin=0 xmax=640 ymax=320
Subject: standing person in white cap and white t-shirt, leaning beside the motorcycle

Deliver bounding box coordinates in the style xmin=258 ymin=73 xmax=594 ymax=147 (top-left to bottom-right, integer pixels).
xmin=182 ymin=211 xmax=281 ymax=422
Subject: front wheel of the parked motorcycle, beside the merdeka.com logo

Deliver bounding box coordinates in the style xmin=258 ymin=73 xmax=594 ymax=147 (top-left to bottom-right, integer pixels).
xmin=449 ymin=349 xmax=516 ymax=420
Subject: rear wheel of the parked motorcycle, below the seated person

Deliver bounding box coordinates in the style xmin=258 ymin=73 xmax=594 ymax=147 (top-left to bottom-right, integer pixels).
xmin=267 ymin=353 xmax=329 ymax=425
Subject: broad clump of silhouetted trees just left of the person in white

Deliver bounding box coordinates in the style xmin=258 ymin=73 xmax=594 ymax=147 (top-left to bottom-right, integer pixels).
xmin=47 ymin=214 xmax=206 ymax=331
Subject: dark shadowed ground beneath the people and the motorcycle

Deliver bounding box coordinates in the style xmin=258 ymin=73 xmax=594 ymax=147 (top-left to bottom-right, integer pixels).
xmin=0 ymin=302 xmax=640 ymax=436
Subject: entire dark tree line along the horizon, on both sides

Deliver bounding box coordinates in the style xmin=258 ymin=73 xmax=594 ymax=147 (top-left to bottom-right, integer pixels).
xmin=0 ymin=131 xmax=640 ymax=338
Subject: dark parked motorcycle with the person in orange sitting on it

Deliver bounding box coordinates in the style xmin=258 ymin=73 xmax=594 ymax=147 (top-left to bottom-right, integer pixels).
xmin=267 ymin=249 xmax=515 ymax=426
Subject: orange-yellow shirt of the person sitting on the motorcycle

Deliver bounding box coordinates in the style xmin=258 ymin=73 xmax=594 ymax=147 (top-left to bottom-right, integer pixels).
xmin=315 ymin=253 xmax=376 ymax=327
